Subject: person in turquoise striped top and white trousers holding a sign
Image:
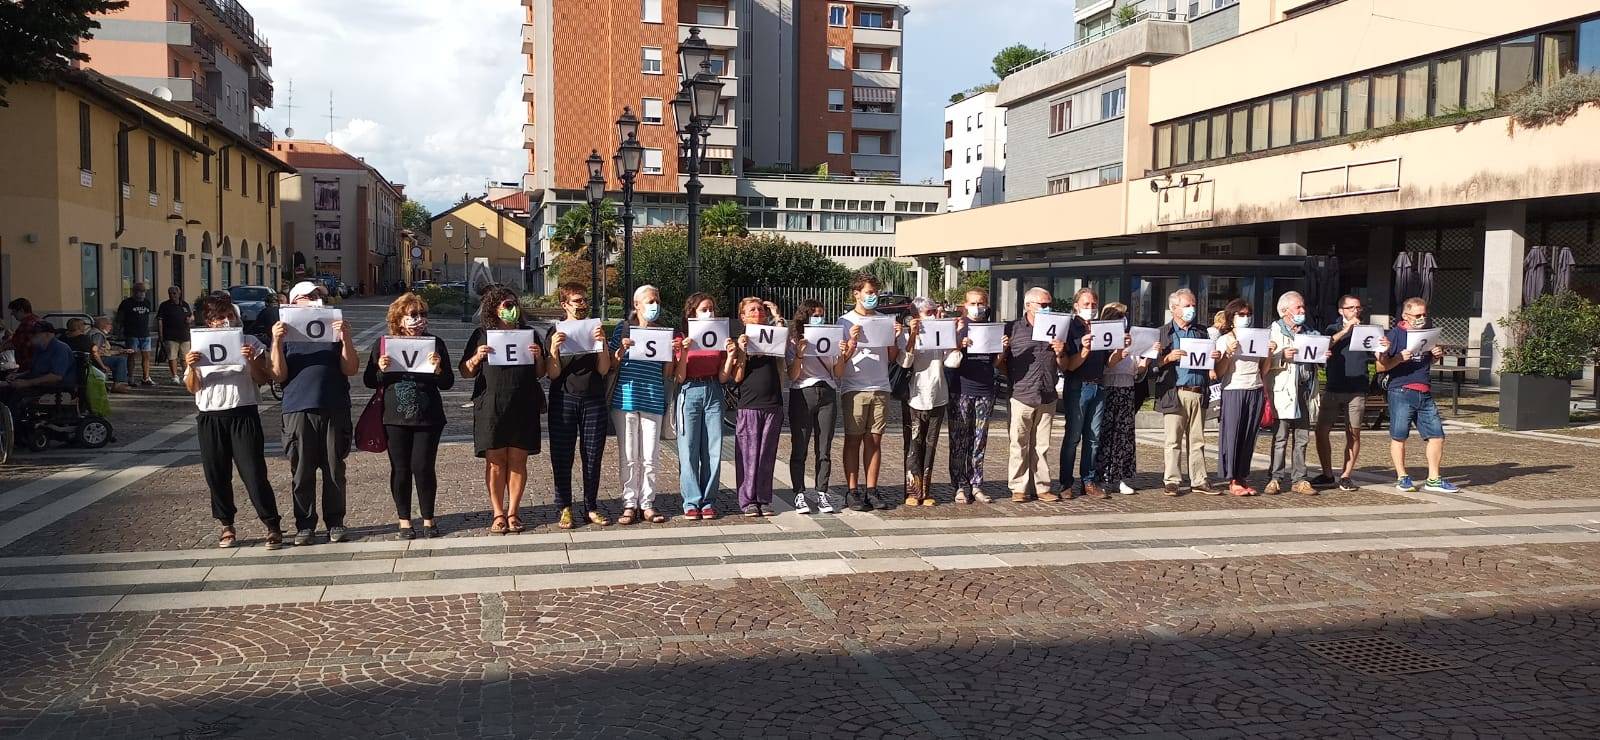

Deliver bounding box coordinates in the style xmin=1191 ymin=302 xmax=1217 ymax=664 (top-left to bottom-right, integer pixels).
xmin=610 ymin=285 xmax=675 ymax=524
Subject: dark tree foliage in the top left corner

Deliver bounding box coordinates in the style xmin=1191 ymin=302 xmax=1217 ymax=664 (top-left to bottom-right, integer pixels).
xmin=0 ymin=0 xmax=128 ymax=107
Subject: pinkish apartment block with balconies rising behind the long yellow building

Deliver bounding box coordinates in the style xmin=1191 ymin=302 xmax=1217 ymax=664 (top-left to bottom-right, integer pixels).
xmin=80 ymin=0 xmax=274 ymax=147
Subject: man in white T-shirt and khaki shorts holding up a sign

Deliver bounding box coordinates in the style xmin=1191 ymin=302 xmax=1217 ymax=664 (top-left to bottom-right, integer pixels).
xmin=838 ymin=274 xmax=901 ymax=511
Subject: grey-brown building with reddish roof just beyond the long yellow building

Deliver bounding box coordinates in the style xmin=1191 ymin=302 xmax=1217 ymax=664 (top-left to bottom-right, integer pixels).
xmin=272 ymin=139 xmax=405 ymax=295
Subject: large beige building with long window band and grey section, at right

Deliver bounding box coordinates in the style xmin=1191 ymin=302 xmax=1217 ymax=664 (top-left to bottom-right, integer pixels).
xmin=896 ymin=0 xmax=1600 ymax=373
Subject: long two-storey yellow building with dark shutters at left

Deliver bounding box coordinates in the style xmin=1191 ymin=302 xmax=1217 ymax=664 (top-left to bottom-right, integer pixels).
xmin=0 ymin=70 xmax=286 ymax=314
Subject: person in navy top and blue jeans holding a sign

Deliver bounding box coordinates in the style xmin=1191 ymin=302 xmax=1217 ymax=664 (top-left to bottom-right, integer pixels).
xmin=1061 ymin=288 xmax=1110 ymax=498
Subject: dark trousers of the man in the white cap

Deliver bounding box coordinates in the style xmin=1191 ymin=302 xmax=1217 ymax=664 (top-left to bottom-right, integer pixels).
xmin=283 ymin=408 xmax=352 ymax=530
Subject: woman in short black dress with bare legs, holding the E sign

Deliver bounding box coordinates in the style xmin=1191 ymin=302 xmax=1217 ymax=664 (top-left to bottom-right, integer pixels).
xmin=461 ymin=285 xmax=544 ymax=535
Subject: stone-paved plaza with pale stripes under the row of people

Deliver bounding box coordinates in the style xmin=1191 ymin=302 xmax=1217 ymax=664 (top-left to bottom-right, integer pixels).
xmin=0 ymin=303 xmax=1600 ymax=738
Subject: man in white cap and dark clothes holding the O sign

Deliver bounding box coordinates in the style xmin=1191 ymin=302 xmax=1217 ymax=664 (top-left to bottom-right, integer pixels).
xmin=272 ymin=280 xmax=362 ymax=545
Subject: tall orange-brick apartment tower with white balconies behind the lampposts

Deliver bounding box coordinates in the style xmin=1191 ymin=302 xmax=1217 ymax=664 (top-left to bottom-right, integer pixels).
xmin=522 ymin=0 xmax=944 ymax=287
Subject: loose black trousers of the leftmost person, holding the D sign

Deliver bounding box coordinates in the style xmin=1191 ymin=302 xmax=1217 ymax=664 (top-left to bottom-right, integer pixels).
xmin=198 ymin=405 xmax=280 ymax=529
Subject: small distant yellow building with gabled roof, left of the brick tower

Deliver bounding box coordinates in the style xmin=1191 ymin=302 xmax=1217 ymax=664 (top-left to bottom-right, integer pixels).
xmin=429 ymin=200 xmax=528 ymax=285
